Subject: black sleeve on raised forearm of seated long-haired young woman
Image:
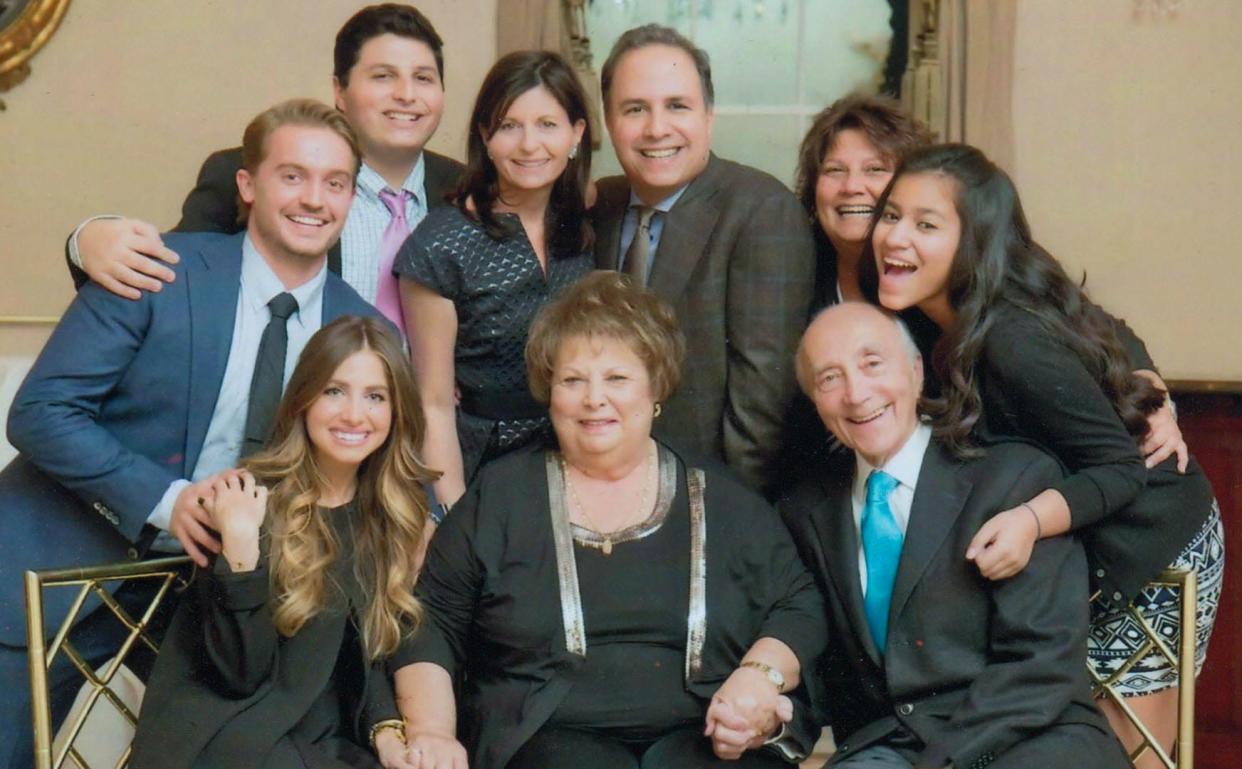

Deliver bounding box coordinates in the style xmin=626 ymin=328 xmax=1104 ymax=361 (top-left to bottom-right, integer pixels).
xmin=199 ymin=559 xmax=278 ymax=699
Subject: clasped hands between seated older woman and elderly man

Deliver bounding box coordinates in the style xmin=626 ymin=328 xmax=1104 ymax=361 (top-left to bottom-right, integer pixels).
xmin=703 ymin=667 xmax=794 ymax=760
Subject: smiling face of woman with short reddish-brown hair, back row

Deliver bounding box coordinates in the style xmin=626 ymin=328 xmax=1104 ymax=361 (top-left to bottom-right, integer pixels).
xmin=815 ymin=128 xmax=893 ymax=252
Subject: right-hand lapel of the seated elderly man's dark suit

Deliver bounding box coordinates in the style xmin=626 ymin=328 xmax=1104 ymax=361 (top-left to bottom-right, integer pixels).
xmin=888 ymin=440 xmax=971 ymax=627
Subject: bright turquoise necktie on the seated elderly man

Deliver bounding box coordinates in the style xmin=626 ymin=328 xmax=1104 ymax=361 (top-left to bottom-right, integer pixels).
xmin=862 ymin=470 xmax=905 ymax=655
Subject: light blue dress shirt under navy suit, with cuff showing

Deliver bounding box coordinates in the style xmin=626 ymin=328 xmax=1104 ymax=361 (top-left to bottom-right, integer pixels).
xmin=147 ymin=235 xmax=328 ymax=550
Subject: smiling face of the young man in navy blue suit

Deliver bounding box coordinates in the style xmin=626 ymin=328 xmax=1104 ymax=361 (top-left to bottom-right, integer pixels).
xmin=237 ymin=123 xmax=356 ymax=265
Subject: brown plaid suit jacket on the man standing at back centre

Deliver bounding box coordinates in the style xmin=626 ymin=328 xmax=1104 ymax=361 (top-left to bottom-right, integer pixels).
xmin=591 ymin=155 xmax=815 ymax=489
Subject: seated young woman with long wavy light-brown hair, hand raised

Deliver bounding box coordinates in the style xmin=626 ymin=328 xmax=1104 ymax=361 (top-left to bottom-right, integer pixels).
xmin=132 ymin=316 xmax=435 ymax=769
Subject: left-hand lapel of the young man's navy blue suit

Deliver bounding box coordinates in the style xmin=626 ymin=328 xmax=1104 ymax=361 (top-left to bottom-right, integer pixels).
xmin=183 ymin=232 xmax=245 ymax=475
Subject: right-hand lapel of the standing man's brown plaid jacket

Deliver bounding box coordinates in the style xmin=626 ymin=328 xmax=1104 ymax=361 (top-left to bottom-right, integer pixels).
xmin=648 ymin=155 xmax=724 ymax=302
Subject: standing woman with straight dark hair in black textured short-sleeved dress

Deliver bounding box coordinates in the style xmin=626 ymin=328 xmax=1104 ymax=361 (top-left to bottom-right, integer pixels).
xmin=394 ymin=51 xmax=592 ymax=504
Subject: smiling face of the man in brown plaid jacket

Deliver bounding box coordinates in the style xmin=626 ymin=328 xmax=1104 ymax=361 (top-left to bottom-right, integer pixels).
xmin=606 ymin=43 xmax=712 ymax=205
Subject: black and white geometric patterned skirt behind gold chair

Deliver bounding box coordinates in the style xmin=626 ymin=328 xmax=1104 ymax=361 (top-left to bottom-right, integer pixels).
xmin=1087 ymin=501 xmax=1225 ymax=697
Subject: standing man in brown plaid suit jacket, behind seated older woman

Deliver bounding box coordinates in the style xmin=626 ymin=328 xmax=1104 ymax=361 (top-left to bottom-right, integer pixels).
xmin=592 ymin=25 xmax=815 ymax=489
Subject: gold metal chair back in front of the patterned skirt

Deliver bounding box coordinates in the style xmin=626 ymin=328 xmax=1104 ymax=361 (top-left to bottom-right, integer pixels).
xmin=1088 ymin=569 xmax=1199 ymax=769
